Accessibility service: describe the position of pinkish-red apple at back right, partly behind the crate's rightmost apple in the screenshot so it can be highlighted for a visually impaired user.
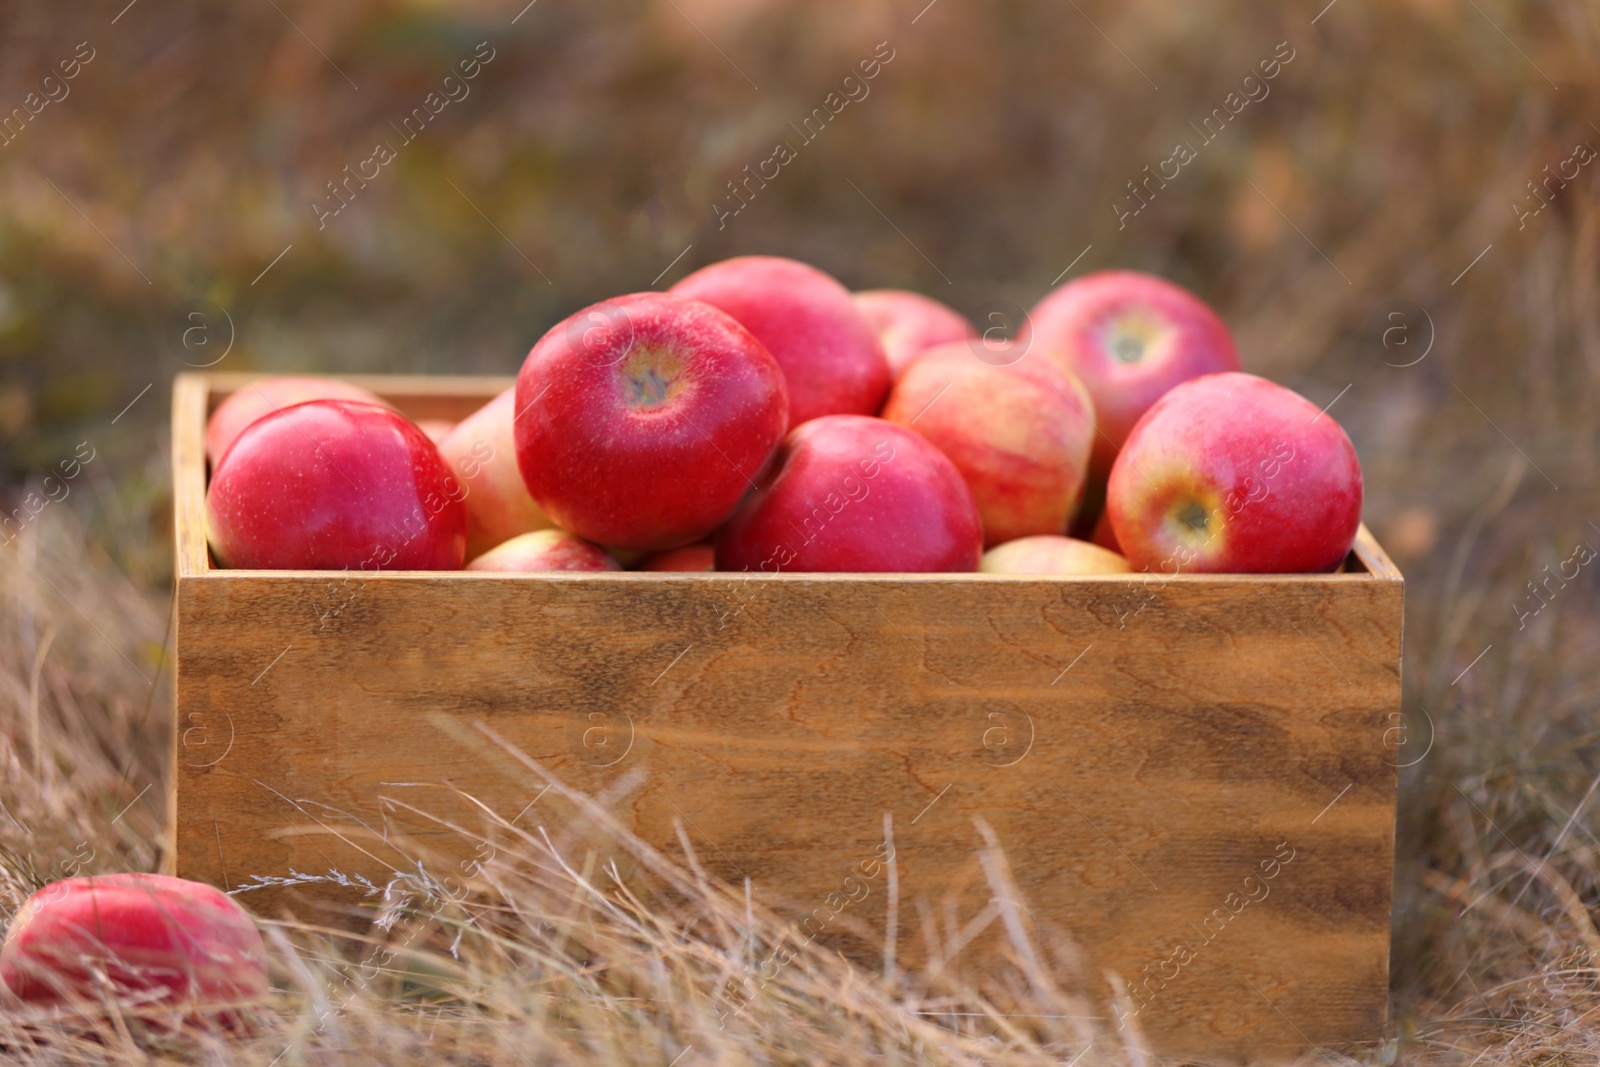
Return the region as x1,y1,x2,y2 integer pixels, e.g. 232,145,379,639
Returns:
1018,270,1238,478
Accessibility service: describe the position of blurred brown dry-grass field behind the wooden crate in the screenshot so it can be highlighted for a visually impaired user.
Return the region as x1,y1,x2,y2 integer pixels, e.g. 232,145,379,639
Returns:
0,0,1600,1064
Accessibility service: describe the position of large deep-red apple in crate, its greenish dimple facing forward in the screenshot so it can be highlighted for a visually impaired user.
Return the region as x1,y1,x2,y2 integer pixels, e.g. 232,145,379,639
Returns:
515,293,789,549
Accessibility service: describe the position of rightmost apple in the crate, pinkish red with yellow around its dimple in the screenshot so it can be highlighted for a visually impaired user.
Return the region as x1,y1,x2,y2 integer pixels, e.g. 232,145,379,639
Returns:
1106,371,1362,573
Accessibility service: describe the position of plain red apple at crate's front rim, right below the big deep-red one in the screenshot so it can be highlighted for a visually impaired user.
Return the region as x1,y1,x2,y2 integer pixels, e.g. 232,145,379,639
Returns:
717,414,984,573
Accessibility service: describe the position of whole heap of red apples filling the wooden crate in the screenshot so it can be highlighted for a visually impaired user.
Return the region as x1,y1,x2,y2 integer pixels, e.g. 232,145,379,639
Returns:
206,256,1362,574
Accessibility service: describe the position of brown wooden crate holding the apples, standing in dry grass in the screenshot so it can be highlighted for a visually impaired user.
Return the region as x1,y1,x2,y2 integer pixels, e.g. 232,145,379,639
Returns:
173,374,1402,1057
